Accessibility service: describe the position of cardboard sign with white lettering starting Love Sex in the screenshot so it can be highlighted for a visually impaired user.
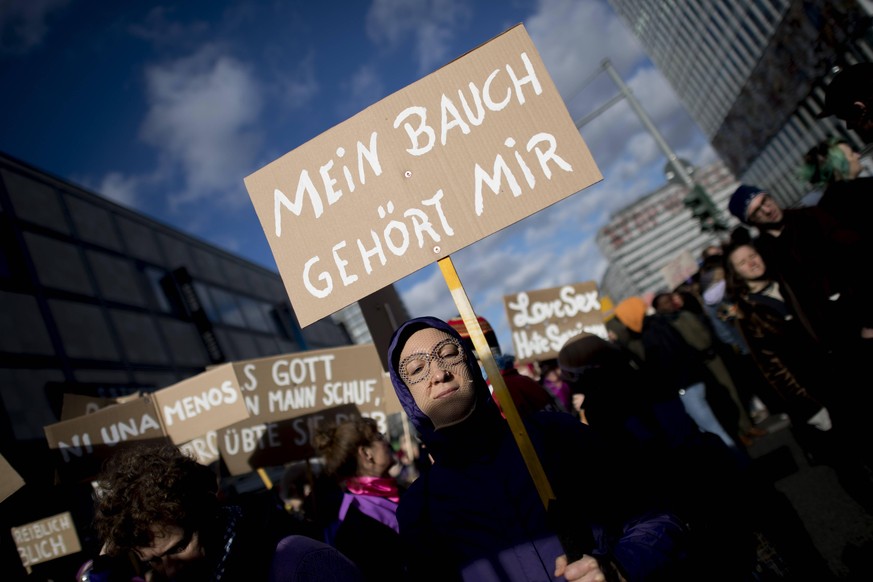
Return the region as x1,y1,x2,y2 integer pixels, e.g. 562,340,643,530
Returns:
503,281,607,363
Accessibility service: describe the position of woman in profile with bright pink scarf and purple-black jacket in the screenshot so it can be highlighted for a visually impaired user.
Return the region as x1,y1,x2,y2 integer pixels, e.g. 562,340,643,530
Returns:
312,417,403,580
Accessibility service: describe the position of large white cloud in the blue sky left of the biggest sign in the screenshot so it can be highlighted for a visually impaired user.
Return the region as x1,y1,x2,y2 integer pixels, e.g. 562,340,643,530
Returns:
140,46,262,207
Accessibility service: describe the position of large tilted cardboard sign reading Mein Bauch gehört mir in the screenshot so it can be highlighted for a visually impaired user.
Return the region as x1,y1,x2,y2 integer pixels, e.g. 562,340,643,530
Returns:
245,25,601,326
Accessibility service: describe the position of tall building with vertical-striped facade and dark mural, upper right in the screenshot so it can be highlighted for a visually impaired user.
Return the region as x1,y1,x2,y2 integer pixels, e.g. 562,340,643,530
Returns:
610,0,873,206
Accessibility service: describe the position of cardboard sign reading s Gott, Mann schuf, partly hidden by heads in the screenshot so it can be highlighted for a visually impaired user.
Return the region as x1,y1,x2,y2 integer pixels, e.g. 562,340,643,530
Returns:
218,344,386,472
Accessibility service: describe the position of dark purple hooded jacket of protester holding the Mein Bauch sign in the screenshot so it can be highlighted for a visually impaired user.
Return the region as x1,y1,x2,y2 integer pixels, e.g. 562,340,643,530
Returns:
388,318,686,582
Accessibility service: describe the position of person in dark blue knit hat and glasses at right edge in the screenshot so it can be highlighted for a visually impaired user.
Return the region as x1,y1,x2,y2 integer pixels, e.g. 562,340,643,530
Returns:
724,178,873,484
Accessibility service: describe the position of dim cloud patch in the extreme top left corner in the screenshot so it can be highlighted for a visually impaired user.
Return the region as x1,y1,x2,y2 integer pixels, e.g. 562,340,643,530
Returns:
0,0,70,55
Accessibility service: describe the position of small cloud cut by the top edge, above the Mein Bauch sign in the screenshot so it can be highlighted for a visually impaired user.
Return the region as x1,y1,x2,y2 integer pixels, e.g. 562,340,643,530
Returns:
367,0,472,75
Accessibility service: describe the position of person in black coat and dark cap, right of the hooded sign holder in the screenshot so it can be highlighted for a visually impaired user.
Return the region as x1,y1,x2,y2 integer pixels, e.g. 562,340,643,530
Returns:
558,334,830,582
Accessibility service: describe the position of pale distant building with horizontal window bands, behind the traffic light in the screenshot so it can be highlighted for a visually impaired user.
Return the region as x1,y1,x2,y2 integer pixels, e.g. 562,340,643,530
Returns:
596,162,739,303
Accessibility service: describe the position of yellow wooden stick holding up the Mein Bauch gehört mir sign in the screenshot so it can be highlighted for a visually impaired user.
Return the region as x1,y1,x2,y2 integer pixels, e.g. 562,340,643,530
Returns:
438,257,555,509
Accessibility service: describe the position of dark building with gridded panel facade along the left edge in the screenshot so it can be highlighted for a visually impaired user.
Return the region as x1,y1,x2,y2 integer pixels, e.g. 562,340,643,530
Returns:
0,154,370,450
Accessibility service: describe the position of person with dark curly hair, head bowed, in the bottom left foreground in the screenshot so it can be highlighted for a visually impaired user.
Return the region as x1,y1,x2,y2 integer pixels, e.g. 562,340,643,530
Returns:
82,444,360,582
